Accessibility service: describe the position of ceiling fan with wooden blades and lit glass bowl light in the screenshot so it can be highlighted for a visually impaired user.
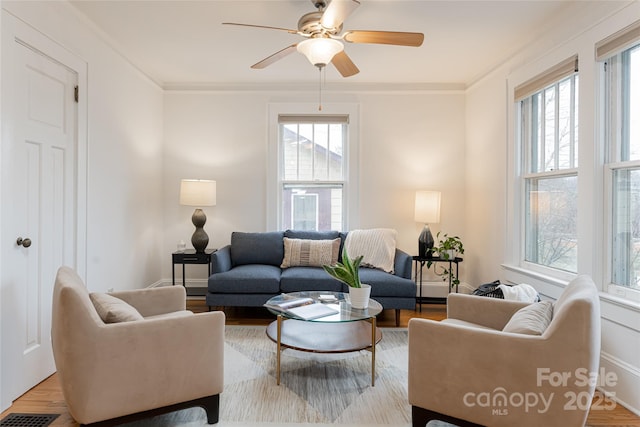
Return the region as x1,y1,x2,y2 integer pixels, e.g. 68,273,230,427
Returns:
223,0,424,77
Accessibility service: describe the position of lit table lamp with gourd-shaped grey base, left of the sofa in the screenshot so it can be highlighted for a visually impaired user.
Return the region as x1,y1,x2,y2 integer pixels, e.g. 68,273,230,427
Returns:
180,179,216,253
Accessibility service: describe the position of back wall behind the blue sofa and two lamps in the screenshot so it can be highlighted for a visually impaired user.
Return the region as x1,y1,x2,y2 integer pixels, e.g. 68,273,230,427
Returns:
163,88,465,282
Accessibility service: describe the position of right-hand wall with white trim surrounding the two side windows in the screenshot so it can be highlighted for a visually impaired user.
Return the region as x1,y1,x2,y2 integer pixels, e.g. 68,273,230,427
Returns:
465,2,640,414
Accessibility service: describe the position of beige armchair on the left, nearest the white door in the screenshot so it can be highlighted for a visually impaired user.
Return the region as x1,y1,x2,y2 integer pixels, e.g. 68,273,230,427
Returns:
52,267,225,425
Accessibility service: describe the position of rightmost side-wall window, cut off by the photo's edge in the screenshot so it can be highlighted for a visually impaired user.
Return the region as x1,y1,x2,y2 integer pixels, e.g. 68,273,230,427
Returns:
596,23,640,300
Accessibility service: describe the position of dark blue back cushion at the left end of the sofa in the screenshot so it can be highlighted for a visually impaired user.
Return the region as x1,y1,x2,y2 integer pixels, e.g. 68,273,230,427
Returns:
231,231,284,266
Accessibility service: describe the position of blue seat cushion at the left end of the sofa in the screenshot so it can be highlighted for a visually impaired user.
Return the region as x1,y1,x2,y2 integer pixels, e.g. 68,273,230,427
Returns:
208,264,280,294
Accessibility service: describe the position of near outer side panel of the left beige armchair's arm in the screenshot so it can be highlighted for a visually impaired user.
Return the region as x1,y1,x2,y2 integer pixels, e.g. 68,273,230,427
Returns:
62,312,224,424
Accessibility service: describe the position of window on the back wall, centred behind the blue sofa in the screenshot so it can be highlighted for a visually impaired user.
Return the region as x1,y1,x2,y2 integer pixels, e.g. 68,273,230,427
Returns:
278,115,348,230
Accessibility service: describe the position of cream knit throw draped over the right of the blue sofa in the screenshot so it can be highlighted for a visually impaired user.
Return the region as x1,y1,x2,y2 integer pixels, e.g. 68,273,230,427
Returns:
344,228,398,274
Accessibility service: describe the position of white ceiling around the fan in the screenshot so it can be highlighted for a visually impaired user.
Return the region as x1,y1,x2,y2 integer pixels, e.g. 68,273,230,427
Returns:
71,0,620,87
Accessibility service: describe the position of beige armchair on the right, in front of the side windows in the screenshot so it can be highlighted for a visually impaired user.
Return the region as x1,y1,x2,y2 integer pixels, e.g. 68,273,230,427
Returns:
409,276,600,427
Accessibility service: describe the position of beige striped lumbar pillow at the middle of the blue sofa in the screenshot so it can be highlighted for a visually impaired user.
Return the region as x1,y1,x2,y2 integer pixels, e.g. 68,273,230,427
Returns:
280,237,340,268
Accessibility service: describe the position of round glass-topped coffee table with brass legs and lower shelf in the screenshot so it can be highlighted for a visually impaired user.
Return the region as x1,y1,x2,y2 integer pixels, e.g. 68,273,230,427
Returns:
265,291,382,386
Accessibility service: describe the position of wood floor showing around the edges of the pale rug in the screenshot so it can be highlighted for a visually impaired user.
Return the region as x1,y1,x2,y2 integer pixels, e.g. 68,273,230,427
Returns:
0,299,640,427
